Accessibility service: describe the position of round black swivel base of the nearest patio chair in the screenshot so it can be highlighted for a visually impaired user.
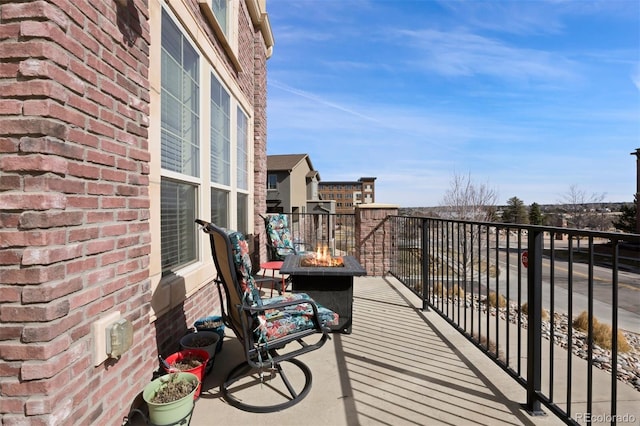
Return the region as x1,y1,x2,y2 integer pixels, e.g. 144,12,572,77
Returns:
220,358,311,413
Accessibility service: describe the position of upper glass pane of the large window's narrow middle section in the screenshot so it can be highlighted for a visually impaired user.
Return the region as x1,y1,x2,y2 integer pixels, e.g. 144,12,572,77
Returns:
211,75,231,186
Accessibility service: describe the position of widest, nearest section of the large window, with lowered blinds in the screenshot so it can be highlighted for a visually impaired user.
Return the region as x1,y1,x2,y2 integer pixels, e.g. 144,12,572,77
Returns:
160,11,200,273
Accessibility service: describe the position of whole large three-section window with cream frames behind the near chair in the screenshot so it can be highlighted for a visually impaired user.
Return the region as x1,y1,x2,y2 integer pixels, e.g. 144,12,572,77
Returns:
159,7,253,276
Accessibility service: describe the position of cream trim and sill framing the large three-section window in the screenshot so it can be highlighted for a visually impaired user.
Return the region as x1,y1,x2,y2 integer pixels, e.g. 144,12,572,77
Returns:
149,0,255,321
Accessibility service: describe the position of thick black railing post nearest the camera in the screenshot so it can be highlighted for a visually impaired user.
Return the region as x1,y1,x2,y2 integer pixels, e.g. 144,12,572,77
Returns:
525,228,544,416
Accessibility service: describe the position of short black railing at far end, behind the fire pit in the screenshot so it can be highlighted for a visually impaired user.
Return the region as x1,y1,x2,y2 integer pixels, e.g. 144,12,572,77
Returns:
274,213,355,256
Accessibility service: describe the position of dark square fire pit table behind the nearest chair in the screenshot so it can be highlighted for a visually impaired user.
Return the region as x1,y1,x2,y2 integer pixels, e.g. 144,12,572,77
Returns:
280,254,367,334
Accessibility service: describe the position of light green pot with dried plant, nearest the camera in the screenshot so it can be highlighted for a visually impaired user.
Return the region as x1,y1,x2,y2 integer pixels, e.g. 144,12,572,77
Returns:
142,372,200,425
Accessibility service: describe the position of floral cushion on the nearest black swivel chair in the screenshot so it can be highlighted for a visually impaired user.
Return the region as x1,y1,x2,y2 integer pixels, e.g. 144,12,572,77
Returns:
227,230,339,342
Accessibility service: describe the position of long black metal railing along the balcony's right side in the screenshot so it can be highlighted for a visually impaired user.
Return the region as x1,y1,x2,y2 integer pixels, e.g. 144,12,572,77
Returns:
385,216,640,424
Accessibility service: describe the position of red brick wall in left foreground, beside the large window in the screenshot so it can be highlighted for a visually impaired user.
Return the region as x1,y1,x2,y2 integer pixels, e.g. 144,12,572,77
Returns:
0,0,156,425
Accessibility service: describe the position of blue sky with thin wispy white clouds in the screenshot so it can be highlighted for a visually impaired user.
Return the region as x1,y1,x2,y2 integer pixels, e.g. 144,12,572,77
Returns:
267,0,640,207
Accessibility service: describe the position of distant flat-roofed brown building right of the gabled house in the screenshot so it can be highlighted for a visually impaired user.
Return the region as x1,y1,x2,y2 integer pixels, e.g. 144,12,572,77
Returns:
318,177,376,213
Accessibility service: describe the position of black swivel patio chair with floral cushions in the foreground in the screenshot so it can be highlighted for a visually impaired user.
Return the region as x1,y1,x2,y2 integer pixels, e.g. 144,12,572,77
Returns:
196,220,338,413
